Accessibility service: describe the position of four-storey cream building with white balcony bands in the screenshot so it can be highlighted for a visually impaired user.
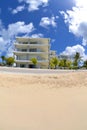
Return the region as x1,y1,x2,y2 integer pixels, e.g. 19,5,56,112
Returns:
14,37,55,68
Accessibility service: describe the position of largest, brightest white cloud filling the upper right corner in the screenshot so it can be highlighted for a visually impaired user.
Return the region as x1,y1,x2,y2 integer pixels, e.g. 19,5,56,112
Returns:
61,0,87,45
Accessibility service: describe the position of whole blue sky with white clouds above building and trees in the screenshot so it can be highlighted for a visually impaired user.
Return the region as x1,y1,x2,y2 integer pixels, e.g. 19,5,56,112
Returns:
0,0,87,60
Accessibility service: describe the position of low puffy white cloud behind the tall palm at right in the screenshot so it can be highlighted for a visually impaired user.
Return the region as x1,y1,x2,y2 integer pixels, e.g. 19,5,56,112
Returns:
60,44,87,60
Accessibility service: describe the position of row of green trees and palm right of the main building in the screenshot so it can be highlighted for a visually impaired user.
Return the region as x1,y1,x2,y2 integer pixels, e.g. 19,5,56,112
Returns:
50,52,87,69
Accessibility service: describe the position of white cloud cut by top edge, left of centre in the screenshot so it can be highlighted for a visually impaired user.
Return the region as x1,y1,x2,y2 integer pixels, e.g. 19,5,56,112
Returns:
18,0,49,11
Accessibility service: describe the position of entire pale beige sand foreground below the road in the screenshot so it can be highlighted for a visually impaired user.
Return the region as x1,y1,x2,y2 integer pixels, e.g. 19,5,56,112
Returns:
0,72,87,130
